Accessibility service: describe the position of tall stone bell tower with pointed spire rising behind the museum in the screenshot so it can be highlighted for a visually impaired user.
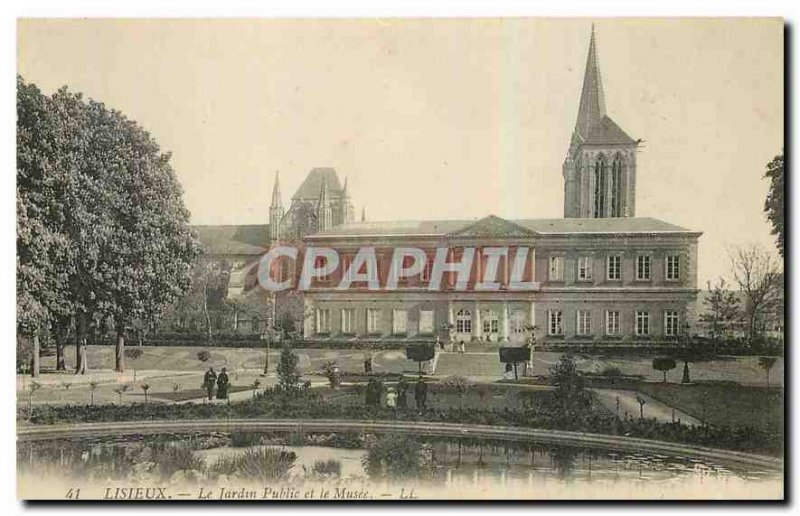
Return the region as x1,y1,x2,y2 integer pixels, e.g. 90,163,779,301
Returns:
562,25,639,218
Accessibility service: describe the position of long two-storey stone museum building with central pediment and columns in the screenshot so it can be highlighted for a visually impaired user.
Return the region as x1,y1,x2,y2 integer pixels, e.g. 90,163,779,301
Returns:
304,216,699,344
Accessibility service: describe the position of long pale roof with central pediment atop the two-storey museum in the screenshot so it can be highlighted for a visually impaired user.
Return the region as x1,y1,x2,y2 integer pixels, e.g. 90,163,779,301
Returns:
308,216,699,239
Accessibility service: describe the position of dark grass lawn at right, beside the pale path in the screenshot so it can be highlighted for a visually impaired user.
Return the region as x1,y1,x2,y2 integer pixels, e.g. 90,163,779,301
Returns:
636,382,783,431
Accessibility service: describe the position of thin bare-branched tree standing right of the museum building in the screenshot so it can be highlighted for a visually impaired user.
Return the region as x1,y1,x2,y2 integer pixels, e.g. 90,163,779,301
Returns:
731,245,783,341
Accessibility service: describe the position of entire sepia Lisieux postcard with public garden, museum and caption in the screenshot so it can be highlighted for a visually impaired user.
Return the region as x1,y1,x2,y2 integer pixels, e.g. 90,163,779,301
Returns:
16,17,787,503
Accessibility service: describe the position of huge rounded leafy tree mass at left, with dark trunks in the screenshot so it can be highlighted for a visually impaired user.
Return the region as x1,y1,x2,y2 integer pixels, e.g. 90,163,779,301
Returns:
17,79,198,373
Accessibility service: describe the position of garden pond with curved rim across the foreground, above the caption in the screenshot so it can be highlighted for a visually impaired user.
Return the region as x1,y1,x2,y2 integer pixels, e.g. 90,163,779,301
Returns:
18,433,782,498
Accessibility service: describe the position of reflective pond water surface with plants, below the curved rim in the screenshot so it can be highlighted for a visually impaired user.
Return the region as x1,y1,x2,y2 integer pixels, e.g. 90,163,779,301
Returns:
17,433,780,486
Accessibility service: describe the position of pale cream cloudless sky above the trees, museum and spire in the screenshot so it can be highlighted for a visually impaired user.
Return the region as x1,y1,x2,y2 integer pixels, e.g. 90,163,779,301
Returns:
17,18,784,287
